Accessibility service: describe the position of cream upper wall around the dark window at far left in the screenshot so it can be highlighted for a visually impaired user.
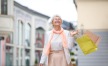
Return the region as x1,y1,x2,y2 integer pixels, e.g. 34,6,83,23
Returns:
0,0,14,35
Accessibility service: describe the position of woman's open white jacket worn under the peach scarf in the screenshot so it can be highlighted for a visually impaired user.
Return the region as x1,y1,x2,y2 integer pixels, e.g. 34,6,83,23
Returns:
40,30,74,65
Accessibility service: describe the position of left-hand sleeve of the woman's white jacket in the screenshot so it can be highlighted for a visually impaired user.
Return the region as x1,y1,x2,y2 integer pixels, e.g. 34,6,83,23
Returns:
40,32,48,64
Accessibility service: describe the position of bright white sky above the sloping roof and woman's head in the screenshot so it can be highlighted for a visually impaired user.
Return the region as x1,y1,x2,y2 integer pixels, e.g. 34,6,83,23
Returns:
15,0,77,22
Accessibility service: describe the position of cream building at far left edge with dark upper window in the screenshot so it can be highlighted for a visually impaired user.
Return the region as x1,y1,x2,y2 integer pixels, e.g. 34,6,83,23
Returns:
0,0,14,66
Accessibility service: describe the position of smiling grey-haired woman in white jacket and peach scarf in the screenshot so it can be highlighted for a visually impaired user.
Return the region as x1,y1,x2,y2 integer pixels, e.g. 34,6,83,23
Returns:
40,15,78,66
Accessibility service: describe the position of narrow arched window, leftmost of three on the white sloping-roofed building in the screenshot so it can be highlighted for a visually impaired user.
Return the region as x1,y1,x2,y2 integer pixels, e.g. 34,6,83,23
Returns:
18,20,23,45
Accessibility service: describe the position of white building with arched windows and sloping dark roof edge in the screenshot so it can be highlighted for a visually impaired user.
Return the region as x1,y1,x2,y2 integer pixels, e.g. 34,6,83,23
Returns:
14,2,49,66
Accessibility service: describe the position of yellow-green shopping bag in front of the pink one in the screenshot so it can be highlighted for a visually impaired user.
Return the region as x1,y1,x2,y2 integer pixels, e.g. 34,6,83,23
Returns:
76,34,97,55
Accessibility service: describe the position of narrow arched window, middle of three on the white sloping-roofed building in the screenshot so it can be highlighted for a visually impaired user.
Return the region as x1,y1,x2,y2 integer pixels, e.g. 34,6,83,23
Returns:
25,24,31,46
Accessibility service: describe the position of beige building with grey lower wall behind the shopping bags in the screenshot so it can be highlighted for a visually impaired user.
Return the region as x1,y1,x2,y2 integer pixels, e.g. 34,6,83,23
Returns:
76,0,108,66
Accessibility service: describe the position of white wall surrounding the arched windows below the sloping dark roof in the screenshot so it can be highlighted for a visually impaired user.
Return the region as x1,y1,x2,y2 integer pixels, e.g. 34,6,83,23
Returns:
14,3,48,65
